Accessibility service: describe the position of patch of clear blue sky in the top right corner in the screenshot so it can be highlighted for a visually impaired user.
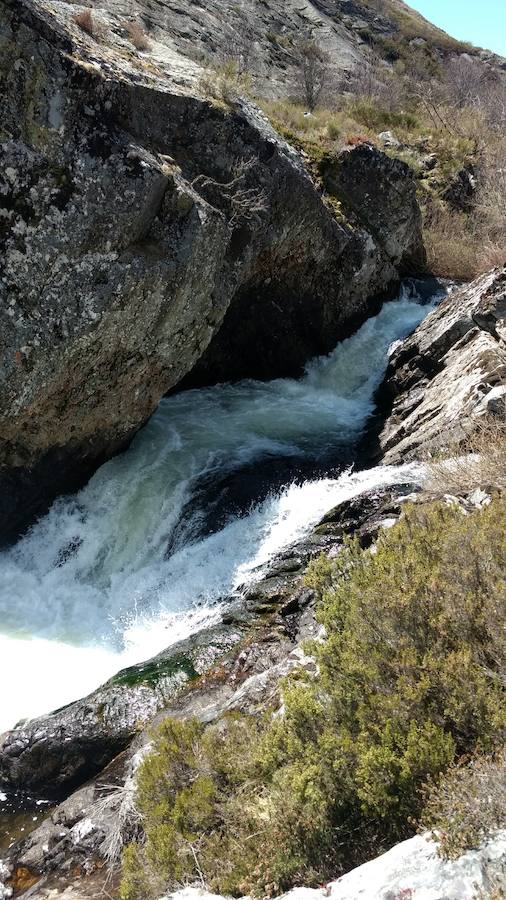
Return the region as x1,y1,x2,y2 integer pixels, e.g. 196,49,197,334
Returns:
406,0,506,56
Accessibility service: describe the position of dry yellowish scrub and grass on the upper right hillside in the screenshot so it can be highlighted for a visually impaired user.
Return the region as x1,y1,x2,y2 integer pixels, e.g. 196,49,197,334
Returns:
253,28,506,280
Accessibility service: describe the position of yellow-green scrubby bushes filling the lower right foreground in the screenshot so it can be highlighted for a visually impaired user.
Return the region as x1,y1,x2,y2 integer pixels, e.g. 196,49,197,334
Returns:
121,496,506,900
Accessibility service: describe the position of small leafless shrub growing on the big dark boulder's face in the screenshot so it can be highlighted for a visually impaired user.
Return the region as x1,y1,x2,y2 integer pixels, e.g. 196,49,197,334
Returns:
192,159,268,227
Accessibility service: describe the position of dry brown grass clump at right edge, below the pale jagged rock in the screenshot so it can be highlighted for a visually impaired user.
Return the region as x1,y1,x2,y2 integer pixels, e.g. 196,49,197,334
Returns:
427,420,506,494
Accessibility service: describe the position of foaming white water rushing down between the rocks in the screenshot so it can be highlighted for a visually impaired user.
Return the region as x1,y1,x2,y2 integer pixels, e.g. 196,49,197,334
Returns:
0,282,440,732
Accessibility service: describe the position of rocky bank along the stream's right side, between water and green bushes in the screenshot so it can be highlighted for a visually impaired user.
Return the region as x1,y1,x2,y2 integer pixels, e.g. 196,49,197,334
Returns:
0,271,505,896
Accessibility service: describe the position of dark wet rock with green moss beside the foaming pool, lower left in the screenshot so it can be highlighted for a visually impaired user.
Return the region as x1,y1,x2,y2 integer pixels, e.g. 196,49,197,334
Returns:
0,617,242,798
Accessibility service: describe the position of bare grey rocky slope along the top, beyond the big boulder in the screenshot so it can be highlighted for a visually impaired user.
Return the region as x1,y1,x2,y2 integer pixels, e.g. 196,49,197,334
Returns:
34,0,506,98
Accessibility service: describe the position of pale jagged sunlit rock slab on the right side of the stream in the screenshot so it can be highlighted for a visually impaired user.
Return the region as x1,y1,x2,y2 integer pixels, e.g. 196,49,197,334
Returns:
378,269,506,463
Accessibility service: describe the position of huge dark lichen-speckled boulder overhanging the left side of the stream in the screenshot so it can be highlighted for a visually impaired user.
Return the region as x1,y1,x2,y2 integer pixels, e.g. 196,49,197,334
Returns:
0,0,421,540
